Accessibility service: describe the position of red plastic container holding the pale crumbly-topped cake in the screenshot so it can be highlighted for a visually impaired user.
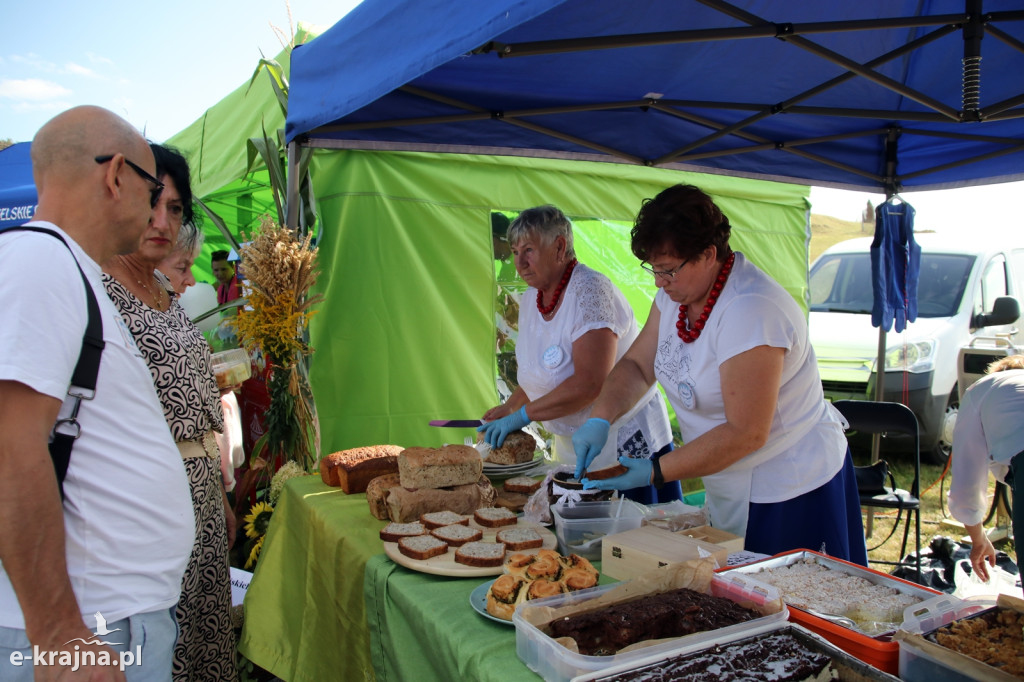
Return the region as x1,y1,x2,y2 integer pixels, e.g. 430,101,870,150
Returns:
724,550,940,675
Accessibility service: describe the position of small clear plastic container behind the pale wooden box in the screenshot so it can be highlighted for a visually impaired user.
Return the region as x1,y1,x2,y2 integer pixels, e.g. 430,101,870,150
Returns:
551,498,644,561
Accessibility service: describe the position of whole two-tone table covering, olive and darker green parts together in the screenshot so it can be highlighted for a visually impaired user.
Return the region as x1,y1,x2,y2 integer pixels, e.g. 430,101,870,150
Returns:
239,476,540,682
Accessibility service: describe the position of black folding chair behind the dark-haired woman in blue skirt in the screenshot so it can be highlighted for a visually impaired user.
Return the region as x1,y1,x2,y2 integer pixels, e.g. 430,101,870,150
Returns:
833,400,921,580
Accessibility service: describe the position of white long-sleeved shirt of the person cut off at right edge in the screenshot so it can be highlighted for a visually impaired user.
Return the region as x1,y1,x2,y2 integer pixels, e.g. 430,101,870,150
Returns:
949,370,1024,525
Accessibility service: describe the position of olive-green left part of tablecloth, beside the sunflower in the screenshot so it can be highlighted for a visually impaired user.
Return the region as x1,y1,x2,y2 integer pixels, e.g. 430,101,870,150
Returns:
239,476,387,682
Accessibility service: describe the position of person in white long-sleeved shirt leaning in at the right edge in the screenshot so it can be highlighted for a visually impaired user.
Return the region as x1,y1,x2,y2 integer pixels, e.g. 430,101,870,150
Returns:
948,355,1024,582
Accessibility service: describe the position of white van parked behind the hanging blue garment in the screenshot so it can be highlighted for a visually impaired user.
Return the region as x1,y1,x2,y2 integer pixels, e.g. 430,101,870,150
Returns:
809,233,1024,464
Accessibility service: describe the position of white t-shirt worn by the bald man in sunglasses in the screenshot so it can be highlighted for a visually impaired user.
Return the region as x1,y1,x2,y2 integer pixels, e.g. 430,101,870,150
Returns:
0,222,196,629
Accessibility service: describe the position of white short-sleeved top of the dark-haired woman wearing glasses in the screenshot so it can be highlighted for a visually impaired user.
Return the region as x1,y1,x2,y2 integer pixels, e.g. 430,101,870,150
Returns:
654,252,847,503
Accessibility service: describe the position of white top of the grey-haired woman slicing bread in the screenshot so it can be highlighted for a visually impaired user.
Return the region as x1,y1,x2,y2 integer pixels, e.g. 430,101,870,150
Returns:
515,263,672,465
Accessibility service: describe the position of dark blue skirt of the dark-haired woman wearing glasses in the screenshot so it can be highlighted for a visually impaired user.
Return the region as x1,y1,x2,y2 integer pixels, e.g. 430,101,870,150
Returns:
744,447,867,566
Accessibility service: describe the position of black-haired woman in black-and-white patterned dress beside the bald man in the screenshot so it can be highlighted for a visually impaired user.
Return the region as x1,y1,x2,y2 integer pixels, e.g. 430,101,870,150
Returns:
103,144,238,681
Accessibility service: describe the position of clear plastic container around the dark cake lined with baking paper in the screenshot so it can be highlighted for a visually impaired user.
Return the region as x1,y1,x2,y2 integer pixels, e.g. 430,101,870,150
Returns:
512,573,788,682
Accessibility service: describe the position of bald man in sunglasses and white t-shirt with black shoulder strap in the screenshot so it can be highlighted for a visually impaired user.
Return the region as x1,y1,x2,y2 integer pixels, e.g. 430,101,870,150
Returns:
0,106,196,682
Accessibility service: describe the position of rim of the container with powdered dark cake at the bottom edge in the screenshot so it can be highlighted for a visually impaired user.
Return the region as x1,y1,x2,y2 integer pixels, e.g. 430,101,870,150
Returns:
572,623,898,682
